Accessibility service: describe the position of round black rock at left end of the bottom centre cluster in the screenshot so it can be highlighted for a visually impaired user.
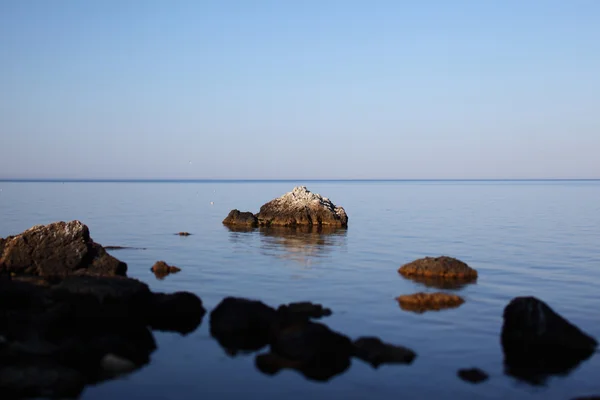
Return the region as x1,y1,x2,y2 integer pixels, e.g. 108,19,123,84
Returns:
210,297,277,355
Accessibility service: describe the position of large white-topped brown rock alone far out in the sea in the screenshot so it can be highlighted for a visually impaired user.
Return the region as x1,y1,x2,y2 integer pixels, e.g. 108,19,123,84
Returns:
256,186,348,227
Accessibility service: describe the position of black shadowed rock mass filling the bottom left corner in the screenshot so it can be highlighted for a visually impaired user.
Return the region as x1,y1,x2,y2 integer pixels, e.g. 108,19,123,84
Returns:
0,275,205,399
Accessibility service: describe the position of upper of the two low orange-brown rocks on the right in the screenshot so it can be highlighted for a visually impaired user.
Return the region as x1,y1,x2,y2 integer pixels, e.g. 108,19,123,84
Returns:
398,256,477,280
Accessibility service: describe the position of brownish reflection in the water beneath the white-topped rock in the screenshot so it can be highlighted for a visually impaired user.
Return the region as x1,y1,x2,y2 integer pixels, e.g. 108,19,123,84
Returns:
258,226,346,264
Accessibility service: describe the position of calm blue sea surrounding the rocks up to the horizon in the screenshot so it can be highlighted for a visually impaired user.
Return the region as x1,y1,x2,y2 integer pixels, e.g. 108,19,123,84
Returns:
0,181,600,400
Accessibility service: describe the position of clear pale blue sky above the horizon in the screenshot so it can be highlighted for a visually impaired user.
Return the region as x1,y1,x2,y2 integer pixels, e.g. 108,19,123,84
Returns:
0,0,600,179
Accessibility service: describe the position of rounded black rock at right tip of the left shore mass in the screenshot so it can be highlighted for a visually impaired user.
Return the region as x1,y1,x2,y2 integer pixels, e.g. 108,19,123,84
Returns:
150,292,206,335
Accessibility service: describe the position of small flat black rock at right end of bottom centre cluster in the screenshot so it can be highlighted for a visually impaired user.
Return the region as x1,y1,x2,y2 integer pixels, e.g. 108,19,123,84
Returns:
354,337,417,368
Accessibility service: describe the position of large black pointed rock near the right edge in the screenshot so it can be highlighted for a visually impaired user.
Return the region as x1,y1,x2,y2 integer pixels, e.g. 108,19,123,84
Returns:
501,297,598,384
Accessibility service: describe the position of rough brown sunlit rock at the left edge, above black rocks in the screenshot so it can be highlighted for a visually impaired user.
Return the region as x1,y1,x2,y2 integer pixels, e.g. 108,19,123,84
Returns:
0,221,127,276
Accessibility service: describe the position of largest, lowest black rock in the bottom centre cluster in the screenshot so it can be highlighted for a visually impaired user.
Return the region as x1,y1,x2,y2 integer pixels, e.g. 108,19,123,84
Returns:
256,321,354,381
